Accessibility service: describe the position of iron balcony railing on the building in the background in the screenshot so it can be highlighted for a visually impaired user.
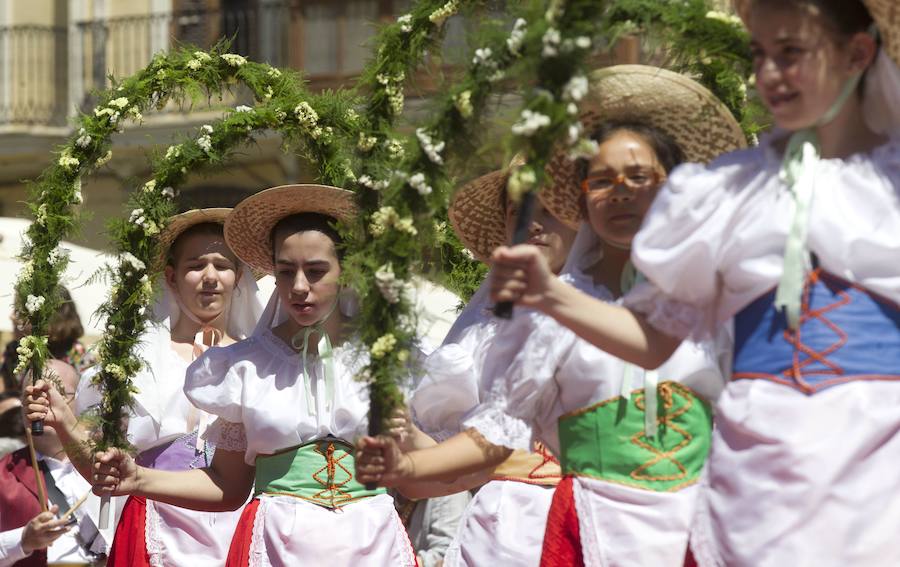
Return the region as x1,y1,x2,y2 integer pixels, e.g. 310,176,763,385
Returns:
0,0,422,130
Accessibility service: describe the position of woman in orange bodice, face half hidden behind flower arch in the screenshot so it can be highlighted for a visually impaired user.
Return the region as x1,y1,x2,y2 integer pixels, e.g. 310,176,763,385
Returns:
396,160,575,567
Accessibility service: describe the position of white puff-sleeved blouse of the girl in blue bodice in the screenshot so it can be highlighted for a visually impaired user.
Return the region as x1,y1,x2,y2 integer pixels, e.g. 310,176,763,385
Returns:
625,137,900,337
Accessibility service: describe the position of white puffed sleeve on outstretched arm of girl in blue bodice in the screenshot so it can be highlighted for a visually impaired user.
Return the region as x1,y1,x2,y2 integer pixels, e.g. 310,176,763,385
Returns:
624,150,761,338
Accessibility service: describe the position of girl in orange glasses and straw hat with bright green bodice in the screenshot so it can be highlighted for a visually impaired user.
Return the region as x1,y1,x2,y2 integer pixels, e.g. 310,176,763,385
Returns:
360,66,744,566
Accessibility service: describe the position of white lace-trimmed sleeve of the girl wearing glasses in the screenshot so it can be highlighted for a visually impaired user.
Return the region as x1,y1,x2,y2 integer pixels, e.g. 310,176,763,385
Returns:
464,313,575,451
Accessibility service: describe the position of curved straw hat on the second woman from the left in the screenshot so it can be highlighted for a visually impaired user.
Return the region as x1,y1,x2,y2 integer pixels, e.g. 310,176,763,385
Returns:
225,184,358,274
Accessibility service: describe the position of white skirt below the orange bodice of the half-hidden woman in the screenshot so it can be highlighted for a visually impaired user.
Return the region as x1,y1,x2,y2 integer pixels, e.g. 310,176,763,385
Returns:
444,480,553,567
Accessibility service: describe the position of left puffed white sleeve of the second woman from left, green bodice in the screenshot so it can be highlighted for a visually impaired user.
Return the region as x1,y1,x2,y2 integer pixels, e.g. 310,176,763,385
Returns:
184,345,244,423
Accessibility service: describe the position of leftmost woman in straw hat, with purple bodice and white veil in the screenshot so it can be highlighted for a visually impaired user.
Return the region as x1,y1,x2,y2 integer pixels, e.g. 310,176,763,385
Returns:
28,209,262,567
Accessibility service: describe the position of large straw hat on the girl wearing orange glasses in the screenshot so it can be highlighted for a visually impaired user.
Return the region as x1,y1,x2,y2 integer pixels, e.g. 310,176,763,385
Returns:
539,65,747,227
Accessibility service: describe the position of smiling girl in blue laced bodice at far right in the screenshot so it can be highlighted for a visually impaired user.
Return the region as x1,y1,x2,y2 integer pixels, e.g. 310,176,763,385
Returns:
494,0,900,566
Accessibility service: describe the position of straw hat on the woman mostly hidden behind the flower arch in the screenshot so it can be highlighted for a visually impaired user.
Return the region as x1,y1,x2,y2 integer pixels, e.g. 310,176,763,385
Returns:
447,156,524,263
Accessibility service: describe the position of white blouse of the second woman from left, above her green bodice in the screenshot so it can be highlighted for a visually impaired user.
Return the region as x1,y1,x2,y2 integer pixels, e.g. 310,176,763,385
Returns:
184,329,369,465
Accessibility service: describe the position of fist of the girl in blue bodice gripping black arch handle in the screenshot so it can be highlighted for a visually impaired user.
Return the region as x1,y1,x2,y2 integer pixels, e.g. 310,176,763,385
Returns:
491,245,556,307
